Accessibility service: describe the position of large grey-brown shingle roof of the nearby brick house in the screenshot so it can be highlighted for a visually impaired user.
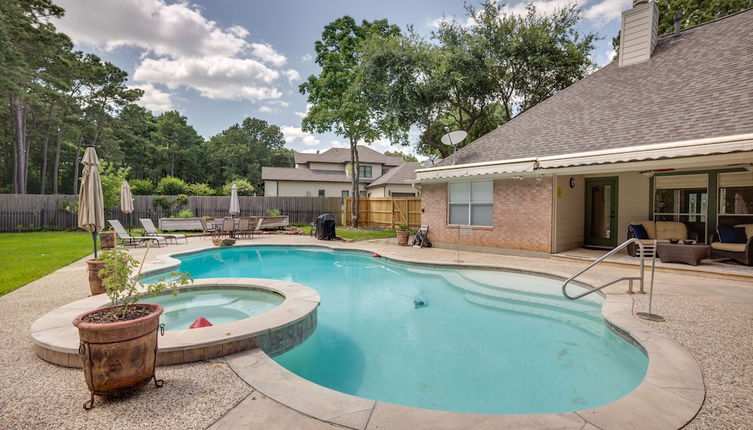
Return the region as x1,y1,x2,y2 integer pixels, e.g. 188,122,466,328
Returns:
438,9,753,166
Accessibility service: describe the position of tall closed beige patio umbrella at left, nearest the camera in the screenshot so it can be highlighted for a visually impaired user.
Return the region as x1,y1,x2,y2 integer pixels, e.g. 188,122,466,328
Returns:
78,146,105,258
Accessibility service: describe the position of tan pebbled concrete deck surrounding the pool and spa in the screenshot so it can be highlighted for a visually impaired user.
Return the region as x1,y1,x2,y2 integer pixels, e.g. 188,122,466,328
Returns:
0,236,753,429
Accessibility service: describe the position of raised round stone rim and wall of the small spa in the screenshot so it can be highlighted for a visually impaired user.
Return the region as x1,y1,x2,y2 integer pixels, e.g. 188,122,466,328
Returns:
31,278,320,367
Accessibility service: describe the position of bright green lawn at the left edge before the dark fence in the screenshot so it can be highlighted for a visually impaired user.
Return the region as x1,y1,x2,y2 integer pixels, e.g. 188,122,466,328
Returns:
0,232,92,296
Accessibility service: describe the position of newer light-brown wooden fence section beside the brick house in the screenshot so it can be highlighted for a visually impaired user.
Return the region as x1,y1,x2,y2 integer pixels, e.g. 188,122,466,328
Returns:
342,197,421,230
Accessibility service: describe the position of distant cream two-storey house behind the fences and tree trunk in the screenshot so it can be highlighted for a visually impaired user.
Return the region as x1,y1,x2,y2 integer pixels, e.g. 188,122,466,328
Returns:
261,145,419,197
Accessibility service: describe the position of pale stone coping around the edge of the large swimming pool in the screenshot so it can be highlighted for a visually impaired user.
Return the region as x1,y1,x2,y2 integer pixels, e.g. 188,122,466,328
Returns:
44,244,706,430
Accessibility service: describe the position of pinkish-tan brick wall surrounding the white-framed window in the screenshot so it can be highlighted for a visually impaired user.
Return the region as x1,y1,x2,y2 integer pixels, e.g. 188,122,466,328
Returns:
421,177,552,252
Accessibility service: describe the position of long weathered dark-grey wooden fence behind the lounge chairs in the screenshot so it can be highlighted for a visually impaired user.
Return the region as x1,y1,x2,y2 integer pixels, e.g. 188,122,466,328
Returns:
0,194,342,231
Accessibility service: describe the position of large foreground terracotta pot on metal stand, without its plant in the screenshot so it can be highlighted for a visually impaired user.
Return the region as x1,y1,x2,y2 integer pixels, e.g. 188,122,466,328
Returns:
73,303,163,409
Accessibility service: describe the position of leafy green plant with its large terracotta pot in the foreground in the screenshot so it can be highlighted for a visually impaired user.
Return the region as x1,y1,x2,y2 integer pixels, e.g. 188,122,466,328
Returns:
73,248,192,409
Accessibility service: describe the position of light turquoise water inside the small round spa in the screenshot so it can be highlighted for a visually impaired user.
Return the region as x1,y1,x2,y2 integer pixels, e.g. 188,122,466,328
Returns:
144,289,284,330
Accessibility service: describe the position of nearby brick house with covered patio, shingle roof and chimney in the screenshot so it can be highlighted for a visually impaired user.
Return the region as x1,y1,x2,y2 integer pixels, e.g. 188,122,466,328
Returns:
416,1,753,253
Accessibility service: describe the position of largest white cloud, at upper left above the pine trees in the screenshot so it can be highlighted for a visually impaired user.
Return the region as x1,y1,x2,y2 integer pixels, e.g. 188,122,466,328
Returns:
55,0,291,105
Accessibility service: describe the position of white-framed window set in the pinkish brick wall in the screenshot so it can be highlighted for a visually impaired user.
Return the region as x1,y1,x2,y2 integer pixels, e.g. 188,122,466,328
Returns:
448,181,493,226
